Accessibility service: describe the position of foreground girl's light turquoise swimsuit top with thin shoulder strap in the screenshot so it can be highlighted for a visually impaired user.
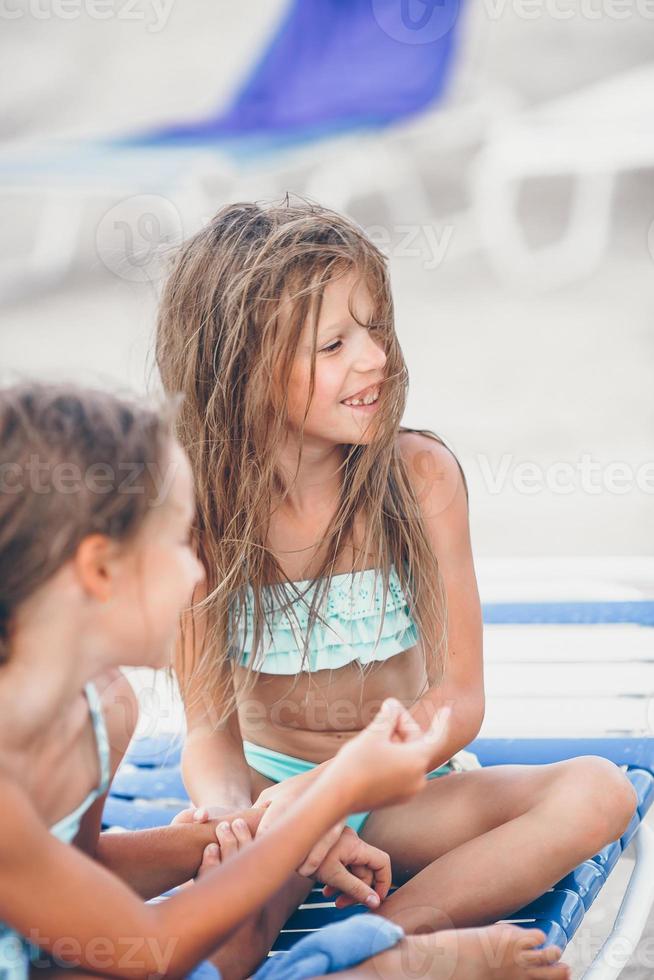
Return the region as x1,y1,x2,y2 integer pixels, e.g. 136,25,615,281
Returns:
0,684,111,980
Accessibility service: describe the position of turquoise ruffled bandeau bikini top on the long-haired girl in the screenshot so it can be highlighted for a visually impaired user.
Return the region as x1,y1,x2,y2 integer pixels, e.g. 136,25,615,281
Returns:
231,566,418,674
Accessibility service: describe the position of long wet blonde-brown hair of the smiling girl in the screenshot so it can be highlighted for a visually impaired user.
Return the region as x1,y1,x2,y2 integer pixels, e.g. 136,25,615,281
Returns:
155,199,464,720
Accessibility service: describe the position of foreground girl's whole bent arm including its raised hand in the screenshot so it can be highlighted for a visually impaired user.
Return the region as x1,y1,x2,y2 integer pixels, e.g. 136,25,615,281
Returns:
0,702,440,978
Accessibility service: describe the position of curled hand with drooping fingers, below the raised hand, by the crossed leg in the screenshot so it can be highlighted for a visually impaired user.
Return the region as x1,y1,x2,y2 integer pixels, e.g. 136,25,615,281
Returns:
308,827,391,909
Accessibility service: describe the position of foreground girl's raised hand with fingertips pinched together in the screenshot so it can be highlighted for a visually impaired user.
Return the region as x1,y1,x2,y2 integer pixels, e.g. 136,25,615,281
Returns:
336,698,452,813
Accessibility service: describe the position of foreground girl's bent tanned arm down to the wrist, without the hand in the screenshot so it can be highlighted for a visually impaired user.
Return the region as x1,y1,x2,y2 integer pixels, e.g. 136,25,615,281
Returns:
0,768,346,978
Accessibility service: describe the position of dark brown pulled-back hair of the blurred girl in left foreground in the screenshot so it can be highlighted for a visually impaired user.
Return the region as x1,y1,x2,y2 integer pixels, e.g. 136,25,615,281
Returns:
0,382,176,663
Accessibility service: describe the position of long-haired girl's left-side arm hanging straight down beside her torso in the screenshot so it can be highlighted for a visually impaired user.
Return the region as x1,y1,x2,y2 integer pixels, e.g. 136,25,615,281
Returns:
175,584,252,814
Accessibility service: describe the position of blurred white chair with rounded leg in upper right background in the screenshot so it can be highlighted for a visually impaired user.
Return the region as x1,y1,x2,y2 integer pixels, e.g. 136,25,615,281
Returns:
472,64,654,289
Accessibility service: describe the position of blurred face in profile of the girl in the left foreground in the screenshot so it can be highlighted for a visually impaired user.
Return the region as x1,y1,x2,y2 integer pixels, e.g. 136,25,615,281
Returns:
108,442,204,667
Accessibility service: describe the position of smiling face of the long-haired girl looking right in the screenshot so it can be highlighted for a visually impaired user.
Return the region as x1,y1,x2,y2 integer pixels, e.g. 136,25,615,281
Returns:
288,271,386,445
